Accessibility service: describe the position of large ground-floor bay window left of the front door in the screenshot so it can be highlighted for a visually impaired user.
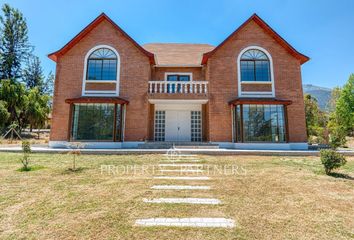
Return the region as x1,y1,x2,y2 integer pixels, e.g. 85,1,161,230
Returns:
71,103,123,141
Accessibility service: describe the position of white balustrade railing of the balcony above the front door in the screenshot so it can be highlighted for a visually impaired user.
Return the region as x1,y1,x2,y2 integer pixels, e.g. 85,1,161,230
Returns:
149,81,208,94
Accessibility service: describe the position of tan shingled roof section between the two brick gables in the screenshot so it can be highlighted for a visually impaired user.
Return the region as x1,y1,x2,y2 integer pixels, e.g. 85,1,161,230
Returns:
143,43,215,67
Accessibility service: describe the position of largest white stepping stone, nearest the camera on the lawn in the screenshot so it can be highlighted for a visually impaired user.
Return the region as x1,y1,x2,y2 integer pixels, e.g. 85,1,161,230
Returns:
135,218,235,228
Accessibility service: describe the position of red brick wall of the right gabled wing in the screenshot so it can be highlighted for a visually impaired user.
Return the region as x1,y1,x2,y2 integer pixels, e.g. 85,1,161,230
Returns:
206,21,307,142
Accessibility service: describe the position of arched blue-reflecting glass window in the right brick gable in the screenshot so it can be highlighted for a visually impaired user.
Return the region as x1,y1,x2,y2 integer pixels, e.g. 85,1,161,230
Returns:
240,49,271,82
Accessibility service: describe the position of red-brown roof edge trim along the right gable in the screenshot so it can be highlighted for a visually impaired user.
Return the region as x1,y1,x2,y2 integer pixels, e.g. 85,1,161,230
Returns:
202,14,310,64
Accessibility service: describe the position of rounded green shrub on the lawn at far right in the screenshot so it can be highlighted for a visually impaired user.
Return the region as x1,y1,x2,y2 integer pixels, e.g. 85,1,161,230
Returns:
320,149,347,175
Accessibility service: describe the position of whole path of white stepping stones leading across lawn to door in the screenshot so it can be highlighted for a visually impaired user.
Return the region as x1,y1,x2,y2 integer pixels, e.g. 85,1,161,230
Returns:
135,149,235,228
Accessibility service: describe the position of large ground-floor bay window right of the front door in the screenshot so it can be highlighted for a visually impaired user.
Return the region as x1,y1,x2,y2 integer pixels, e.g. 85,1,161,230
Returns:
234,104,286,142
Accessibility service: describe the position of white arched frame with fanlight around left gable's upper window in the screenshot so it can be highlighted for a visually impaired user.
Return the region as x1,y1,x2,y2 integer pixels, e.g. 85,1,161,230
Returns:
82,45,120,96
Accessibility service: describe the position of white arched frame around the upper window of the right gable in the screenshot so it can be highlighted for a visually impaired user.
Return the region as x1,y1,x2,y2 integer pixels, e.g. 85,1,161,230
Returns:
237,46,275,97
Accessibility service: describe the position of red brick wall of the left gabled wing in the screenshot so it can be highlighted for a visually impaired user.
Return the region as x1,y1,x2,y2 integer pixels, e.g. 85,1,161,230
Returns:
50,21,151,141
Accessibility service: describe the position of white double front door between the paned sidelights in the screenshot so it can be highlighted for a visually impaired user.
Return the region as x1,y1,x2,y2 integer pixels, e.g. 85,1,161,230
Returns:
165,110,191,142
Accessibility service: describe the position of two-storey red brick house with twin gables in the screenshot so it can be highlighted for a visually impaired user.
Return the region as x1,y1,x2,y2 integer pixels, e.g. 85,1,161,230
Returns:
49,14,309,149
